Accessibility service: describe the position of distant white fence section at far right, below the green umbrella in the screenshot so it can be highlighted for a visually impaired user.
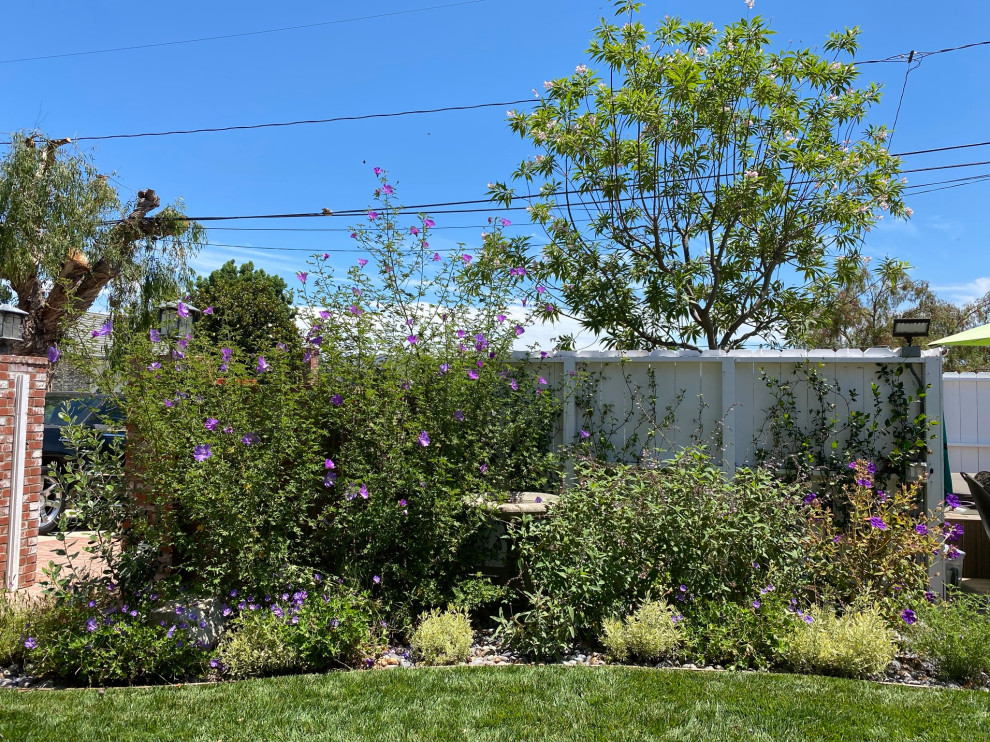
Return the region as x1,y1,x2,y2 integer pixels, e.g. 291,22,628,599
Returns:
942,373,990,473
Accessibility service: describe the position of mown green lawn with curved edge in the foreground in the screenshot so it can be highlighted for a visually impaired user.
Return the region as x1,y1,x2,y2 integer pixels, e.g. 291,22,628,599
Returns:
0,666,990,742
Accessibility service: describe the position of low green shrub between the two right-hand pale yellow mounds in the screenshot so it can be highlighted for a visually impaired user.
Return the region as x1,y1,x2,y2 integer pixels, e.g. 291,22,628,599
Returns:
682,588,791,669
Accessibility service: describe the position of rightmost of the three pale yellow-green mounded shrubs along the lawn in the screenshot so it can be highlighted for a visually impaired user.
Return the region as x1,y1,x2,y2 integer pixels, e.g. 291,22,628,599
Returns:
783,607,897,677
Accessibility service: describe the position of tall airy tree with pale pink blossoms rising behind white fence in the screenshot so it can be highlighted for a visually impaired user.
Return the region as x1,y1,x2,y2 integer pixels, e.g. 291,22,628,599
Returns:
489,2,910,349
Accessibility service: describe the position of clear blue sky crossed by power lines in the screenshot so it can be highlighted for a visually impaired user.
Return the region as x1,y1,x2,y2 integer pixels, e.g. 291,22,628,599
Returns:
0,0,990,348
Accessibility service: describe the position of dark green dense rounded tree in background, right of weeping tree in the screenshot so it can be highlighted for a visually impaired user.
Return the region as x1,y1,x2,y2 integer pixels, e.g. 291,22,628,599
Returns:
190,260,300,353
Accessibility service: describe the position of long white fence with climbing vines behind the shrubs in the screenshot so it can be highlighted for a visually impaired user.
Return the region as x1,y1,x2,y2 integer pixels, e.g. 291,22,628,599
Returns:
516,348,944,507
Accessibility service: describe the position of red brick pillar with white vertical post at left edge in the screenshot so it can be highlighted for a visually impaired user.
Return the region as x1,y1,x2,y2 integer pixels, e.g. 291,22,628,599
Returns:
0,355,48,590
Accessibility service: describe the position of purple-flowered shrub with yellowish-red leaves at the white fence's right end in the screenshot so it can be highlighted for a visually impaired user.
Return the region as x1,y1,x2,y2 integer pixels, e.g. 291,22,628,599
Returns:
804,461,952,621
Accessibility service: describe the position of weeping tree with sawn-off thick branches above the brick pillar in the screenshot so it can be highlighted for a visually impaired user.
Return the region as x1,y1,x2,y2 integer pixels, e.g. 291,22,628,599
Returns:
0,133,201,355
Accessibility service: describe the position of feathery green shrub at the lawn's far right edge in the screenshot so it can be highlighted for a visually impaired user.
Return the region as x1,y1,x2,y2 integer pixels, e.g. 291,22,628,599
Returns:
907,591,990,680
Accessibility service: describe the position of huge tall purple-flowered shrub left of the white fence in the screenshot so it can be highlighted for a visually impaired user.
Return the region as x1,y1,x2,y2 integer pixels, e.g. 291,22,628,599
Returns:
76,171,560,620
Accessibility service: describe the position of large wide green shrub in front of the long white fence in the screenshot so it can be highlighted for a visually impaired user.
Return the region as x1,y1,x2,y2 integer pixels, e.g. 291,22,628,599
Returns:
499,450,805,656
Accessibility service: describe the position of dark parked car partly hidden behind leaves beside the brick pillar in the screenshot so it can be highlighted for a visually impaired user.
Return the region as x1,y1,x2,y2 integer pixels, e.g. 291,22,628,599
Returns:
38,392,124,534
